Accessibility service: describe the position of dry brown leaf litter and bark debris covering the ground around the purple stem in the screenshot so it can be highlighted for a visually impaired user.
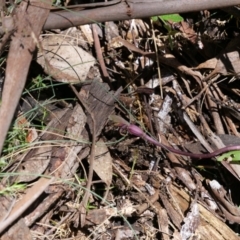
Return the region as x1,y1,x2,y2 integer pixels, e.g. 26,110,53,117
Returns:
0,4,240,240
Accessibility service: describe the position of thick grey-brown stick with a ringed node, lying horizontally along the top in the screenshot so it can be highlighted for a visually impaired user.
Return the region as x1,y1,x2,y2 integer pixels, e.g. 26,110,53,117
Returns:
44,0,239,30
